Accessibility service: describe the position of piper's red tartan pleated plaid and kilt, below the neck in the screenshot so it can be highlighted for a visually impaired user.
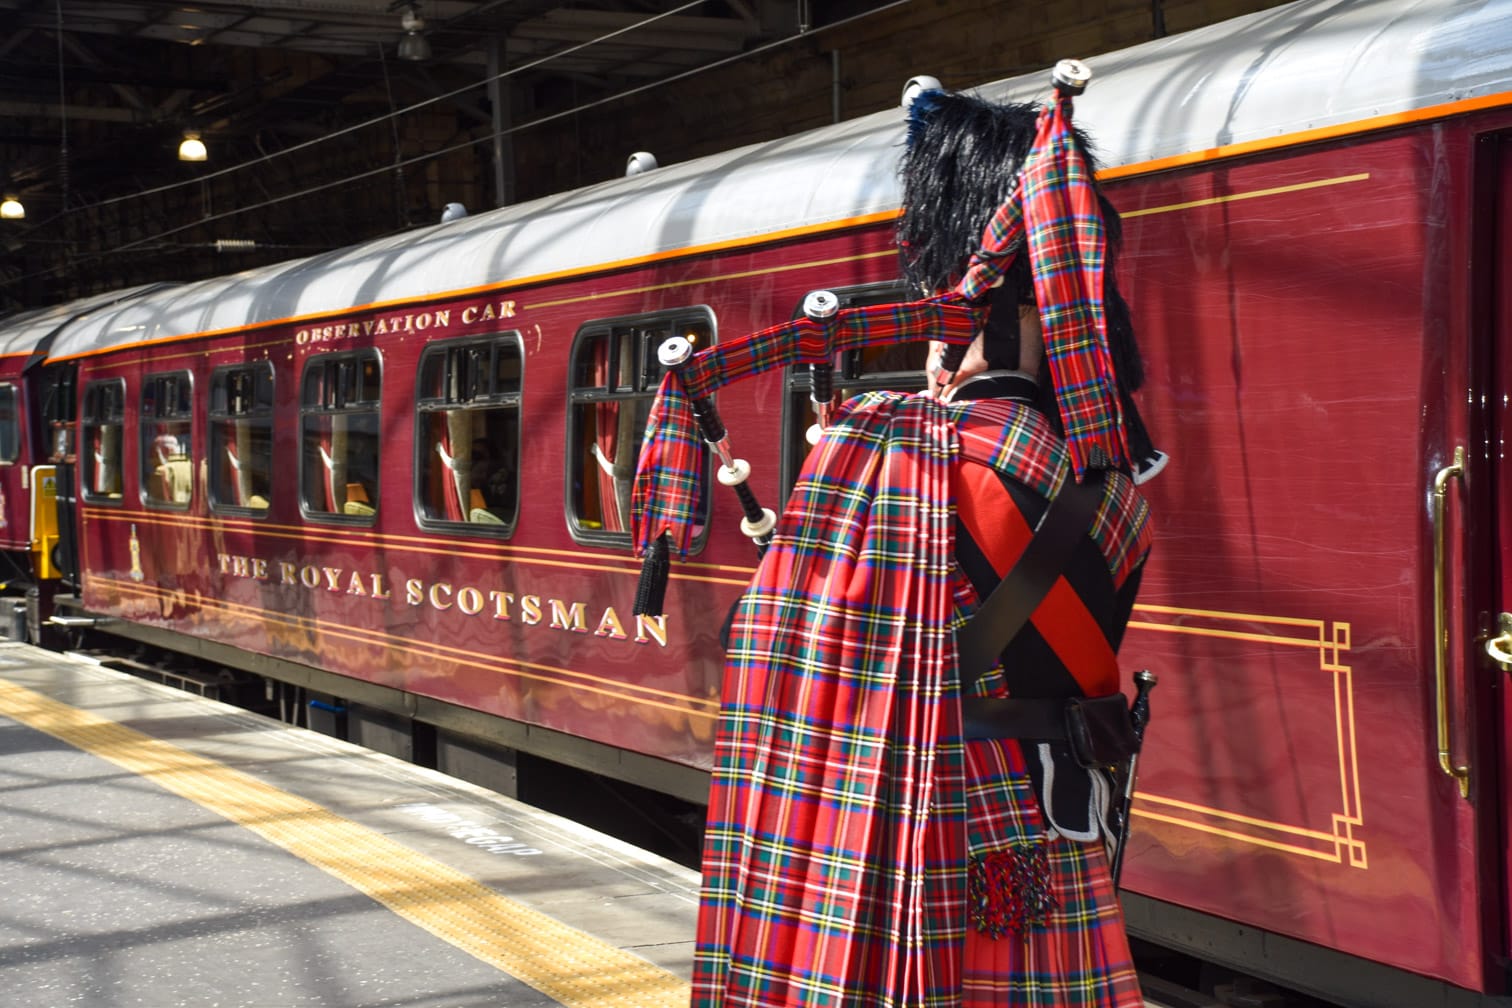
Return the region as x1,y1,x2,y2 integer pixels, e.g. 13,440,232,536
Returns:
694,393,1148,1008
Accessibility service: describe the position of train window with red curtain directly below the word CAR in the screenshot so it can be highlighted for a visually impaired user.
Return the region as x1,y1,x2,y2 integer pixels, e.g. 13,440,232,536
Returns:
414,332,525,533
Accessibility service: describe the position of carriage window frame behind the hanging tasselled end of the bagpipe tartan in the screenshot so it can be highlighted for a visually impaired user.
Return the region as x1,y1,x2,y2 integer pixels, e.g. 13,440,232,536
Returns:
562,304,718,555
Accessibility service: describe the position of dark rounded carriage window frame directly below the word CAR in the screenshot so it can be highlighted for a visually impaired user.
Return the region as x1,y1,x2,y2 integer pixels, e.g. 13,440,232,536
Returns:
411,329,525,538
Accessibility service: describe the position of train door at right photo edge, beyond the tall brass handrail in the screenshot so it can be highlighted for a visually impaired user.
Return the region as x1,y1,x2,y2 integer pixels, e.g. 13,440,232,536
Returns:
1470,131,1512,991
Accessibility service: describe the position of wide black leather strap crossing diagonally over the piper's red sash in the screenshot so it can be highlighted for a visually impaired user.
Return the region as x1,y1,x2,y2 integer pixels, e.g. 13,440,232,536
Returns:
956,468,1107,695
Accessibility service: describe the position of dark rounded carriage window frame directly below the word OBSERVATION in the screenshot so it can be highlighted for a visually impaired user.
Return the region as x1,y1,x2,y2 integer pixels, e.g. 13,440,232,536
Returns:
298,348,383,526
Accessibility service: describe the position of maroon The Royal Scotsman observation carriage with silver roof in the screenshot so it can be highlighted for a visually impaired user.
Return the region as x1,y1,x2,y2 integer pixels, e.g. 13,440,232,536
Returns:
17,0,1512,1008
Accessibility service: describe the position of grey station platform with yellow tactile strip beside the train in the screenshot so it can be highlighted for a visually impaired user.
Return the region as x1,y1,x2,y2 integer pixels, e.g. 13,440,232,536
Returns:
0,642,699,1008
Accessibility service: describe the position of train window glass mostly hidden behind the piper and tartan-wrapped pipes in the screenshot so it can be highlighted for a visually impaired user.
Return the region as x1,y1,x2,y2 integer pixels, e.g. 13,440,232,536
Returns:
782,281,928,497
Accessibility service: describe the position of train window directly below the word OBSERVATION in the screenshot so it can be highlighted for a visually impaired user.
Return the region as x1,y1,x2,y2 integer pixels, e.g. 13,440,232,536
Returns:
299,351,381,523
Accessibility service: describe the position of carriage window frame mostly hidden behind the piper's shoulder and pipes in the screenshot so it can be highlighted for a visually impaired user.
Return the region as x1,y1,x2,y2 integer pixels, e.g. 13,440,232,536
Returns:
777,280,927,502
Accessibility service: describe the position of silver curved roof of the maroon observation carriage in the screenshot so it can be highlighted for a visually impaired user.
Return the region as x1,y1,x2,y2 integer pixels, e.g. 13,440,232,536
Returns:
41,0,1512,358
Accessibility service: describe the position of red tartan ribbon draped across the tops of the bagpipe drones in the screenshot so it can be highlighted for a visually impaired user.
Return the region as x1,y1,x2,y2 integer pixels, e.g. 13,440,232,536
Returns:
631,87,1129,568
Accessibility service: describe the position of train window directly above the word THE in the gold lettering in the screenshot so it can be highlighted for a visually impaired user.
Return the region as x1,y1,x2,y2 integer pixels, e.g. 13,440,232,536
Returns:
209,361,274,514
